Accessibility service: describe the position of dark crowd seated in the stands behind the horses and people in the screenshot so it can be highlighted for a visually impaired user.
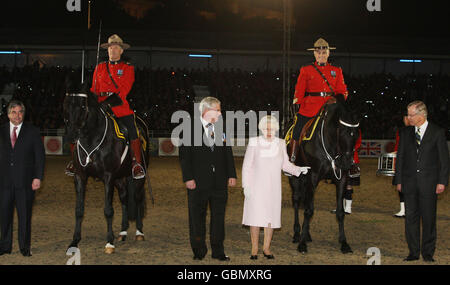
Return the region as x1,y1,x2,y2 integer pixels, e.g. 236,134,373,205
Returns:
0,64,450,139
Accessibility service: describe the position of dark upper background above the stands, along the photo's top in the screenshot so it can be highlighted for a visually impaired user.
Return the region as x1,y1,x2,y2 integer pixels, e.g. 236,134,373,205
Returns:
0,0,450,54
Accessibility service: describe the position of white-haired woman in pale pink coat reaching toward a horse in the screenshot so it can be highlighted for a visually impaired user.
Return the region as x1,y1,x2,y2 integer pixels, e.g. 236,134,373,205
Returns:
242,115,309,259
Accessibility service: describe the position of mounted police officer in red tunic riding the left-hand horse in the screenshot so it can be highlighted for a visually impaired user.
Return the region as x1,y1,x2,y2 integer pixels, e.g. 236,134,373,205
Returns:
66,34,145,179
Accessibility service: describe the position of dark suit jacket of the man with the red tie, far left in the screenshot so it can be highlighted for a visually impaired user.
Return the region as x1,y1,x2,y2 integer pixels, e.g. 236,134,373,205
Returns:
0,122,45,189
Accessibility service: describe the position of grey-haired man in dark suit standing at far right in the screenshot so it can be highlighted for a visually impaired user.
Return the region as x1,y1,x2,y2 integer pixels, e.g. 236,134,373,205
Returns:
394,101,449,262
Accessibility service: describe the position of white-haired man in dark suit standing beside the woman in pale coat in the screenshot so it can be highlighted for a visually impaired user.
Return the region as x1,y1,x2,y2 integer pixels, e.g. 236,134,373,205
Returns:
179,97,236,261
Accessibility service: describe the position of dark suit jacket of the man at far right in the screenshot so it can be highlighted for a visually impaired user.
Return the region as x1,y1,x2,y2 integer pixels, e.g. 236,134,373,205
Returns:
394,121,449,194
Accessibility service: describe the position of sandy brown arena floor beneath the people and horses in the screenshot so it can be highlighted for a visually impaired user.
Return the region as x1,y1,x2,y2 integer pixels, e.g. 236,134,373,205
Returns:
0,156,450,265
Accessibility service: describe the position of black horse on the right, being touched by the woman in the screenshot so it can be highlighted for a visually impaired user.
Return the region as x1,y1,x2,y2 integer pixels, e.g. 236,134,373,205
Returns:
289,95,359,253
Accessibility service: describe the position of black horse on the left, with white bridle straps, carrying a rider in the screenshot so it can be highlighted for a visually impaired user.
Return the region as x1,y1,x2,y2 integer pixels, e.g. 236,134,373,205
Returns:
64,83,151,253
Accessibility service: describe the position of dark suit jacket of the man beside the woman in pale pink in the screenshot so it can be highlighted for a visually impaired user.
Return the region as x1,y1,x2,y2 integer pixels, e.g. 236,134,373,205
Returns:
179,118,236,190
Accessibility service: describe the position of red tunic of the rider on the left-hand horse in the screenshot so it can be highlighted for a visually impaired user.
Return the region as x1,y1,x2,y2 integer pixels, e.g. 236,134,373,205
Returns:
91,61,134,118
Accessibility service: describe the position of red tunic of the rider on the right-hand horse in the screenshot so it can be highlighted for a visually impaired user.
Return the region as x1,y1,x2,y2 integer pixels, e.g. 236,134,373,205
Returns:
294,62,348,117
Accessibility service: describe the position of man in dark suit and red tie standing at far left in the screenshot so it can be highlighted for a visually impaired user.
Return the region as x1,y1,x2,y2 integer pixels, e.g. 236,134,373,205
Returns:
0,100,45,256
